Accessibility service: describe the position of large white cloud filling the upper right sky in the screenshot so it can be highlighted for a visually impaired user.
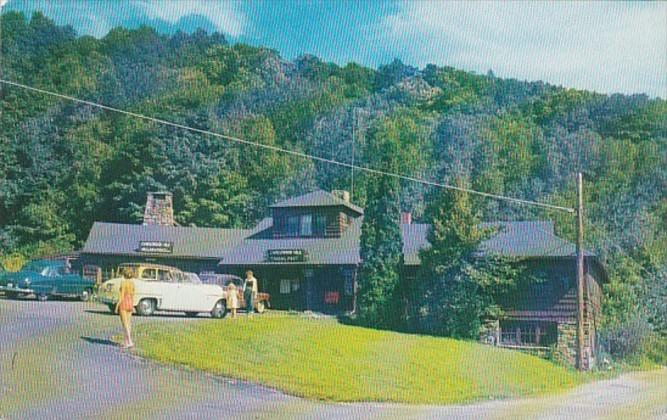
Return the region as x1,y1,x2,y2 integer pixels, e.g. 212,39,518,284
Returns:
375,2,667,98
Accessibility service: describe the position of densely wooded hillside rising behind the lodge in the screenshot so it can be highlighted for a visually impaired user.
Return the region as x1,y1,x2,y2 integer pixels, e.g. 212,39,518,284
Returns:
0,13,667,342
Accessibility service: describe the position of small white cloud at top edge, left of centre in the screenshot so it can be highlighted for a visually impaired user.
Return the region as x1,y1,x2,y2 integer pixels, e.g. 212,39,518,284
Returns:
136,0,247,37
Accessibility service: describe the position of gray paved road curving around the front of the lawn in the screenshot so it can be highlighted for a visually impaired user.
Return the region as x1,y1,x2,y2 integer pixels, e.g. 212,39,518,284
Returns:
0,298,667,420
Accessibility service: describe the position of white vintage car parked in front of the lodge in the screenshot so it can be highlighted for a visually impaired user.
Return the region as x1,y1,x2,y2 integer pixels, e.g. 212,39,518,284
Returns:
98,263,227,318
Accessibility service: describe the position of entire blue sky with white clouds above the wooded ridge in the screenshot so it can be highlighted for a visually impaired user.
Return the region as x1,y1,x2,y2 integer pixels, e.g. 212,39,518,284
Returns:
0,0,667,98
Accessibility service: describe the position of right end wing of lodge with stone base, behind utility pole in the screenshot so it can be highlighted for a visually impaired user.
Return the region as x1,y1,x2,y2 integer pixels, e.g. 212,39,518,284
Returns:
481,222,607,366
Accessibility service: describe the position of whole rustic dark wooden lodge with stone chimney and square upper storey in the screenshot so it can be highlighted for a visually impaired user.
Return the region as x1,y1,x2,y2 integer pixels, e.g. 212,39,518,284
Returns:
80,190,606,364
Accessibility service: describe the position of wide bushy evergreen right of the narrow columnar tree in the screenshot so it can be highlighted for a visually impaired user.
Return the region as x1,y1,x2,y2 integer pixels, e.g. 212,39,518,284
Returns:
410,182,522,338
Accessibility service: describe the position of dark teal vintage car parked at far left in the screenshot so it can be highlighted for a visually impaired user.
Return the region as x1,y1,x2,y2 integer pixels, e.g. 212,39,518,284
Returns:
0,260,95,301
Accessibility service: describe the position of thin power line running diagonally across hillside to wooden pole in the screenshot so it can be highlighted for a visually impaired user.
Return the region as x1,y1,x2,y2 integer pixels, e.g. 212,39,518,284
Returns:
0,79,576,213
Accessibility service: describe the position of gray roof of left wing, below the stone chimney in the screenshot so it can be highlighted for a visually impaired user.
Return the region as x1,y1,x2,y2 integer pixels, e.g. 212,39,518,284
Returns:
81,222,250,259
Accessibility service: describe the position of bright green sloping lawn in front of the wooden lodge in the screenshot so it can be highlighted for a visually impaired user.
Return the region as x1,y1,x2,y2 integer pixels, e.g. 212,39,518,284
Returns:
136,313,585,404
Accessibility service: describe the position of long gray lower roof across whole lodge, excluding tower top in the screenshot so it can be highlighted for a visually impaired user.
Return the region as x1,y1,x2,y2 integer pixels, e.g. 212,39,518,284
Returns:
82,216,593,265
